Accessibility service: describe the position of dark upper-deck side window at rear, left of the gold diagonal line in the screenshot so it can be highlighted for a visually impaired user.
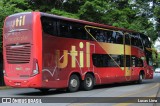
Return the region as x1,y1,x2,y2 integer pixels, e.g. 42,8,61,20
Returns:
41,16,87,40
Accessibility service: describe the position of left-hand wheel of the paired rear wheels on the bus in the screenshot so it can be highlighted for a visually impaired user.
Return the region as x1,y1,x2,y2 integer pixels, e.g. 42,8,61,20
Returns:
68,74,80,92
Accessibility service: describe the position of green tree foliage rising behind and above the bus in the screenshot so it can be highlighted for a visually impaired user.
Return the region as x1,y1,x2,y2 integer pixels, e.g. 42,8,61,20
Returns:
0,0,160,52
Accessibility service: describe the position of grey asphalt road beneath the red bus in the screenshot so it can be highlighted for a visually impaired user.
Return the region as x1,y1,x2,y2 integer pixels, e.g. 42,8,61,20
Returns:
0,73,160,106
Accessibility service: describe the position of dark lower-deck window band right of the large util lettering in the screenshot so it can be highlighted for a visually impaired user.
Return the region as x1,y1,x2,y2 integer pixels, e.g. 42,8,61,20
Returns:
92,54,134,67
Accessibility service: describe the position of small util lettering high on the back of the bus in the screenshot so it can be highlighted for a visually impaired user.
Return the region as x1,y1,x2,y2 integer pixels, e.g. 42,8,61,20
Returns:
11,15,26,28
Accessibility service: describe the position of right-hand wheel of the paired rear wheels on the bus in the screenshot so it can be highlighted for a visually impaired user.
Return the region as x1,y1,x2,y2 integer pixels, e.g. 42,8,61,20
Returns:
81,74,94,91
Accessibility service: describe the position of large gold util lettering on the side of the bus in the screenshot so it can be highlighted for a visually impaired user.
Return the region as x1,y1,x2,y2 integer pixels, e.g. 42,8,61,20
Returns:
56,42,90,68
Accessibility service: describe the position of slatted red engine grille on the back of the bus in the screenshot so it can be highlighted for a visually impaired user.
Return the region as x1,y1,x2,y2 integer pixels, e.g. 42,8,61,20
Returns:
6,44,31,64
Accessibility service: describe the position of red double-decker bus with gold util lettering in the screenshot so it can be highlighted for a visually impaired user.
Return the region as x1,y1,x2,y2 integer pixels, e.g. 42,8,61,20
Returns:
3,12,153,92
